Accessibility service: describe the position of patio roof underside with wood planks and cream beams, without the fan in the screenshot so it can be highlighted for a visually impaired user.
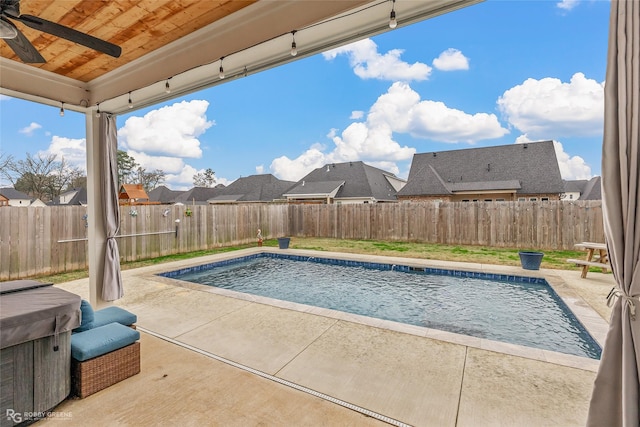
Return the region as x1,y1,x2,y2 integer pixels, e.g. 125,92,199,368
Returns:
0,0,482,114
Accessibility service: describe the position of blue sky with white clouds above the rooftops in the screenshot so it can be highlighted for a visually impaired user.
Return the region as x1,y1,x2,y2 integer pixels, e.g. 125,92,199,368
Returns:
0,0,609,190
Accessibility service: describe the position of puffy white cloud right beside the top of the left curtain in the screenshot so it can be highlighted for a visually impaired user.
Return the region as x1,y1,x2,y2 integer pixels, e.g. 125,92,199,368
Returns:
118,100,214,158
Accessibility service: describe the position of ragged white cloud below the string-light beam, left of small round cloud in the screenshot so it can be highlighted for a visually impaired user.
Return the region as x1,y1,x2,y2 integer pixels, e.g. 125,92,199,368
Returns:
322,39,432,82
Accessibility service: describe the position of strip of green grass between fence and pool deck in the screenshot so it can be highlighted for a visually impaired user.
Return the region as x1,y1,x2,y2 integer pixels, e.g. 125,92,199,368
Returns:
39,237,600,283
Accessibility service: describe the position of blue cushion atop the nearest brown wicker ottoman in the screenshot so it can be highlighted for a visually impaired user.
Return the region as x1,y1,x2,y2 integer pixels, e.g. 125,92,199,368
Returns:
71,323,140,362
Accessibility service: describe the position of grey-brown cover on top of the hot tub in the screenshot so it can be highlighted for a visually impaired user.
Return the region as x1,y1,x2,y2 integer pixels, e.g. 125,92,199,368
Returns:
0,280,80,348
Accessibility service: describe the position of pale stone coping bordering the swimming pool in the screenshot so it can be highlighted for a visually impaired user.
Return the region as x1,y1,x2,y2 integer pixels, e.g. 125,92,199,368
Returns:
148,247,609,372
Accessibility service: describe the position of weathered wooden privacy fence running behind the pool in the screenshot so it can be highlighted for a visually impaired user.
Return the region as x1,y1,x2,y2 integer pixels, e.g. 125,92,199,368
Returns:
0,200,604,280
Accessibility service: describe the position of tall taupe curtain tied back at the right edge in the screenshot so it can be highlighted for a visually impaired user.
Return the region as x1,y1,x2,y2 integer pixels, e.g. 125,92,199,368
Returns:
587,0,640,427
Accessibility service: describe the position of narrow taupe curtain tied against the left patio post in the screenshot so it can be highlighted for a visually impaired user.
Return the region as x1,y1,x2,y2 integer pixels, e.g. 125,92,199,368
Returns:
99,113,124,301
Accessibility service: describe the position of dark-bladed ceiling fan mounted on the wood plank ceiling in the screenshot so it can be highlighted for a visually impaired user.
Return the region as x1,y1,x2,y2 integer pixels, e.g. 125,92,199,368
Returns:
0,0,122,64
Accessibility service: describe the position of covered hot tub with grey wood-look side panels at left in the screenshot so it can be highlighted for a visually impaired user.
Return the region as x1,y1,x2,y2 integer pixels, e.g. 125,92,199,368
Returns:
0,280,81,426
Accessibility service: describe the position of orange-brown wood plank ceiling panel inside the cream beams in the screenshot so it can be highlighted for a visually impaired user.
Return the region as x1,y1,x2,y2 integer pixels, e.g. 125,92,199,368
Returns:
0,0,257,82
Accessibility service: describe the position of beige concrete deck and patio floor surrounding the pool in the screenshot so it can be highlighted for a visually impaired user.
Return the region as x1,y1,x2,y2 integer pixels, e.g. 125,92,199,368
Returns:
39,248,614,426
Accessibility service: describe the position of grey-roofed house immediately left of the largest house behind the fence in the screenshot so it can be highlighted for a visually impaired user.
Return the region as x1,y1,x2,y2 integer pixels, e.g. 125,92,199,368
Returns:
282,162,406,204
